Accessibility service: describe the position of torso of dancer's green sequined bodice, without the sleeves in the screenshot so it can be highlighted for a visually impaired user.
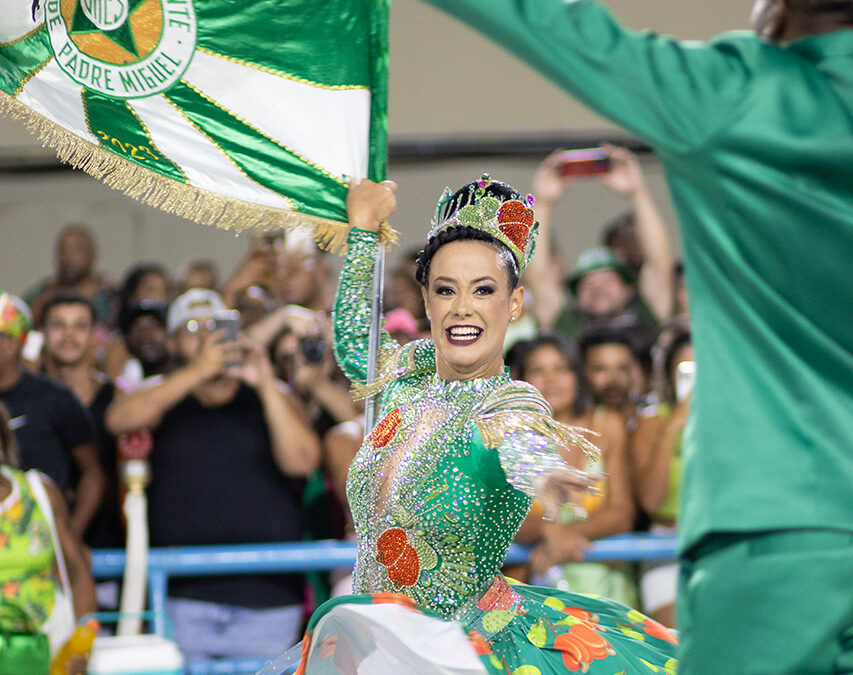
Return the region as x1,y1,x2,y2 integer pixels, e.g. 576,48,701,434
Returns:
347,375,530,616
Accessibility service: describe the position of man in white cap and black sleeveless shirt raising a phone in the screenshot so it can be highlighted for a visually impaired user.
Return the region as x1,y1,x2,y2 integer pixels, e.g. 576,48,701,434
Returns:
107,289,319,661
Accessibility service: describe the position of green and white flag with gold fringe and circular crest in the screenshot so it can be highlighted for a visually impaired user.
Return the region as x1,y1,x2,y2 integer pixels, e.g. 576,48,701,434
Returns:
0,0,389,243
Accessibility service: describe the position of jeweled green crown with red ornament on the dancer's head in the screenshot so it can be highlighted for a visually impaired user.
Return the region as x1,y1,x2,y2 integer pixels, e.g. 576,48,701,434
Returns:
427,173,539,276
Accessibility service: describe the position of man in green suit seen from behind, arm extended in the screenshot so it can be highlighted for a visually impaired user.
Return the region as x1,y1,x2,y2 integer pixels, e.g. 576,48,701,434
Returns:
428,0,853,675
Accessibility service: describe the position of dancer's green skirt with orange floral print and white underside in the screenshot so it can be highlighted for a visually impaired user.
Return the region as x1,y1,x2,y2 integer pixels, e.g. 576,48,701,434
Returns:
261,576,677,675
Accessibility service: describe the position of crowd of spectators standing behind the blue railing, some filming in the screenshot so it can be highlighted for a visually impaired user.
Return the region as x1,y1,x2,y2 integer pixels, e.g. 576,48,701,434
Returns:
0,148,694,659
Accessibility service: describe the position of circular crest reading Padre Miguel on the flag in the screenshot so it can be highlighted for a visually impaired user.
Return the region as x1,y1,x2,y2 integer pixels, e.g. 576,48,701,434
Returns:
44,0,196,99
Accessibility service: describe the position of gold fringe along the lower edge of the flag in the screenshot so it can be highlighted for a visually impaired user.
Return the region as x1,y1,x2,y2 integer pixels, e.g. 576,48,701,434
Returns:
0,91,399,252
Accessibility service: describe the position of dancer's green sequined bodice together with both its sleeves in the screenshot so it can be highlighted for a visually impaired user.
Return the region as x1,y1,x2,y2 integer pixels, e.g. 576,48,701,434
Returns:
334,230,571,617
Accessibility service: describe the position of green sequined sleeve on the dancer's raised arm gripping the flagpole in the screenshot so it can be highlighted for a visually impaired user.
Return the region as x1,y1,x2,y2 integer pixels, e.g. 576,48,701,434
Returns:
334,228,400,385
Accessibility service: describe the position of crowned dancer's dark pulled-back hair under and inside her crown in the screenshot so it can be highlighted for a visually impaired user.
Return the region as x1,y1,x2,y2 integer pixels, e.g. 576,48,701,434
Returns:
415,180,521,290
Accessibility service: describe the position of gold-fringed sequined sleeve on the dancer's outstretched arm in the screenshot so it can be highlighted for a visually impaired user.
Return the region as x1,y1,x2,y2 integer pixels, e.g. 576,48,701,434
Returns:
477,382,599,497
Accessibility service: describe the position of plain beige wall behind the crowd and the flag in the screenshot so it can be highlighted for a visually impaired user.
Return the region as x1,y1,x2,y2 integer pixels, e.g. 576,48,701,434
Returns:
0,0,749,292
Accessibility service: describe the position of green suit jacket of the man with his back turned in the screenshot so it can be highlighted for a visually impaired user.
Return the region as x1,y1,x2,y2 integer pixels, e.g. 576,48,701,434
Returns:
428,0,853,549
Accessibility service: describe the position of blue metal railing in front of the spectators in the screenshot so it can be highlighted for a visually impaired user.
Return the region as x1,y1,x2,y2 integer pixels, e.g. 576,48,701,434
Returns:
92,534,676,675
